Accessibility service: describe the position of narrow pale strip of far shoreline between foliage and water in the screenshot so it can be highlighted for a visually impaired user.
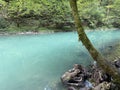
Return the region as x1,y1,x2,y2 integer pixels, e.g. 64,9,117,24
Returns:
0,27,119,35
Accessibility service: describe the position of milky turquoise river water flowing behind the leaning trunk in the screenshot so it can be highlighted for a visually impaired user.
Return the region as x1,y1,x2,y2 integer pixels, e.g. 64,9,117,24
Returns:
0,31,120,90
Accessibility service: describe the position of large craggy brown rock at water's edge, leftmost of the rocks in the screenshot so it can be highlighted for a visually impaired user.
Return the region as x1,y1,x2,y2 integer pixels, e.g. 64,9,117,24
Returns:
61,64,92,90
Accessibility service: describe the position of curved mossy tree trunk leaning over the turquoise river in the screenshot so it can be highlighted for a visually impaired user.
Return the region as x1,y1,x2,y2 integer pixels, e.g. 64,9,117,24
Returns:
70,0,120,84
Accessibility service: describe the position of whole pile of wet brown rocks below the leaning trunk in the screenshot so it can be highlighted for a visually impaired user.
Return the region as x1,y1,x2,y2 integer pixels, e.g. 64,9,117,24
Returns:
62,62,120,90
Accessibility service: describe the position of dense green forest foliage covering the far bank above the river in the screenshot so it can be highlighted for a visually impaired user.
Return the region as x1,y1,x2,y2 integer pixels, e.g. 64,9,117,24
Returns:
0,0,120,32
